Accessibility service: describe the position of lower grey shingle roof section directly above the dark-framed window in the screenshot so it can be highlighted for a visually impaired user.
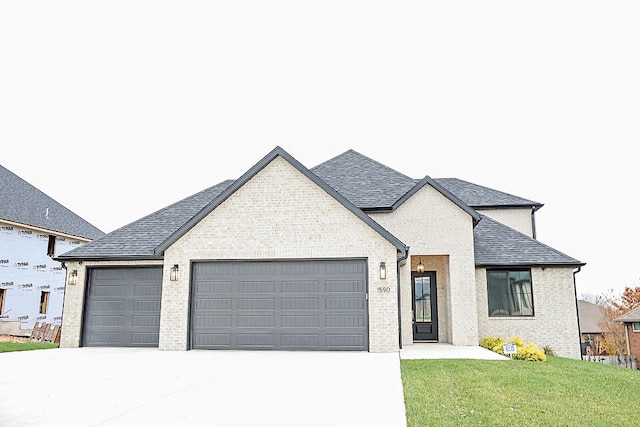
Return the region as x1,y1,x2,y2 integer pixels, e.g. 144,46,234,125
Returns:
473,215,585,267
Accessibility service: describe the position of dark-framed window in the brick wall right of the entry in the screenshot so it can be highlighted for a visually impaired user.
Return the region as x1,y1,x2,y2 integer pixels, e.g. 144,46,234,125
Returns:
487,270,533,317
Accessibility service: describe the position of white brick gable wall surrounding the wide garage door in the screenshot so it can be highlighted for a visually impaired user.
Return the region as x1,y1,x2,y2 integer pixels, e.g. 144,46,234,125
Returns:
160,157,398,352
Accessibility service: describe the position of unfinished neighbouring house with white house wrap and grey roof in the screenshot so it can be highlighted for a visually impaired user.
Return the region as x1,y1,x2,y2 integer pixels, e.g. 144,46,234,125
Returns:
0,166,104,335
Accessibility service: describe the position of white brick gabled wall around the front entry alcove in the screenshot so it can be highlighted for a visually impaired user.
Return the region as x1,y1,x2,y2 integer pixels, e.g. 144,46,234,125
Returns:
371,185,478,345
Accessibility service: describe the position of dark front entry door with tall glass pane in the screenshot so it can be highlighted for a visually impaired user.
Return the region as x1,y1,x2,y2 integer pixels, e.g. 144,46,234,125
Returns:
411,271,438,341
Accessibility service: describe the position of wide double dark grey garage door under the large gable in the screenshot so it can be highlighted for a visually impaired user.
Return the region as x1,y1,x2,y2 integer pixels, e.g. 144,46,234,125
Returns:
191,260,368,351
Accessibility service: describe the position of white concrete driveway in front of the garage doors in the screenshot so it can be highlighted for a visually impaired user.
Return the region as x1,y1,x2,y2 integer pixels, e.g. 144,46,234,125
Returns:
0,348,406,427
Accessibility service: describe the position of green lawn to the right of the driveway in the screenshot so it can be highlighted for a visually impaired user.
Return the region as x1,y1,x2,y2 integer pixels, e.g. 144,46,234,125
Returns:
401,356,640,427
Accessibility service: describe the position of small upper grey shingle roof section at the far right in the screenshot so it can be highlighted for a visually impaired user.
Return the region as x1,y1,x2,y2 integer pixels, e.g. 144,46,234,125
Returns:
436,178,542,208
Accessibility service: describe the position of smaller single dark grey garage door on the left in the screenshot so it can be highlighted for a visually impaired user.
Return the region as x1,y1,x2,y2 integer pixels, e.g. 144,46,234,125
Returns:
82,267,162,347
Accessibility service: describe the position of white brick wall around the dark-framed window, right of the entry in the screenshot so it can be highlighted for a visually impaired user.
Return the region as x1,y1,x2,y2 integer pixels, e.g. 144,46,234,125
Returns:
476,268,580,359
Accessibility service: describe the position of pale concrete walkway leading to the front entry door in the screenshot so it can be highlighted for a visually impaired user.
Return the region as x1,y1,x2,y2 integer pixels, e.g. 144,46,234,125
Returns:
400,343,510,360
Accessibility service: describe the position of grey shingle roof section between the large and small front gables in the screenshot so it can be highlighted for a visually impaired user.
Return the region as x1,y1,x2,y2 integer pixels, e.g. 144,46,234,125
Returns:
311,150,419,209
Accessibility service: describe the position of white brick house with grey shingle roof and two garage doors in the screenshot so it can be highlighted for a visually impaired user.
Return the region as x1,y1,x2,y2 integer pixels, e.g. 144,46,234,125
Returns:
57,147,584,359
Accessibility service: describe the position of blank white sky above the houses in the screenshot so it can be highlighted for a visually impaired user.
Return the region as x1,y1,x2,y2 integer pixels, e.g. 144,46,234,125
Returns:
0,0,640,300
